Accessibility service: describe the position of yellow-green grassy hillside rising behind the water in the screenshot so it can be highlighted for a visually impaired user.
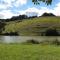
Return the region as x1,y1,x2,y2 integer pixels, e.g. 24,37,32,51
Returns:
4,17,60,35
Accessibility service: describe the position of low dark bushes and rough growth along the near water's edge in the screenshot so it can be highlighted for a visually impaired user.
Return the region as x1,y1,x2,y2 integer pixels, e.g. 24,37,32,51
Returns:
23,39,60,45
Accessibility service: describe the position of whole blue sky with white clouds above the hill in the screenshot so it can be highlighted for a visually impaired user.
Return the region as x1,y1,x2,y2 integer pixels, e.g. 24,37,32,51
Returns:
0,0,60,19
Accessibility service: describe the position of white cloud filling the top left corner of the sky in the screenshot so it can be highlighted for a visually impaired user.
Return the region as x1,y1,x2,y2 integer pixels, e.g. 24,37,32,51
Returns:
0,0,27,9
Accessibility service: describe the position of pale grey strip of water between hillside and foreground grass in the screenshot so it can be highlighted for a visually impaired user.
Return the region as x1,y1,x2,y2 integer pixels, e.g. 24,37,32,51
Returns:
0,36,60,43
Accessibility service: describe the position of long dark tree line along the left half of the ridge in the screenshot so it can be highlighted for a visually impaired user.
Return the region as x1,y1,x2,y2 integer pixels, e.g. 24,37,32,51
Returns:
0,15,37,22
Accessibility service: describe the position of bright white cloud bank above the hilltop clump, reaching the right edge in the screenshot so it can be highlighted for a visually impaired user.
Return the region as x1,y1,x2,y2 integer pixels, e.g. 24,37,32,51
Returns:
25,3,60,16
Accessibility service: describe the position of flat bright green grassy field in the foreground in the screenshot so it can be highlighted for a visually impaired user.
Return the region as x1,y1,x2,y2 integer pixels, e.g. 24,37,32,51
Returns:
0,44,60,60
